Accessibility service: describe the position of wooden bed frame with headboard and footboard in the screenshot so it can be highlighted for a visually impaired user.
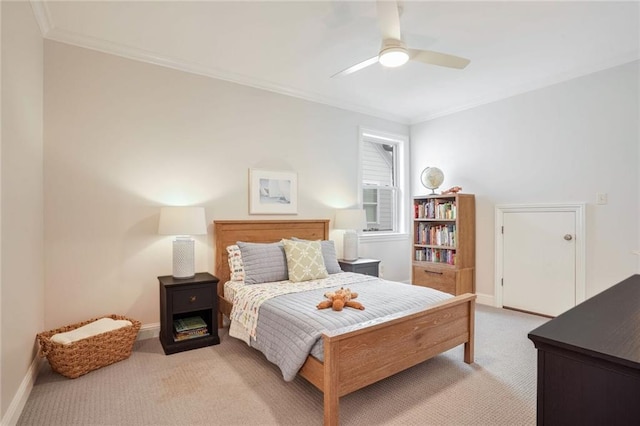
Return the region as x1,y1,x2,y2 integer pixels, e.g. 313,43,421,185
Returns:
213,219,476,425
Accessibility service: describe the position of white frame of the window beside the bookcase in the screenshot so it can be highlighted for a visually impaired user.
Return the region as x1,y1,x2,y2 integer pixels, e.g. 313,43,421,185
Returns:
358,127,409,241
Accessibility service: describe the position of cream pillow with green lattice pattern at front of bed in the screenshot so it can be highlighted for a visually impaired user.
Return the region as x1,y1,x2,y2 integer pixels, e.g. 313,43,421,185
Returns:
282,240,329,282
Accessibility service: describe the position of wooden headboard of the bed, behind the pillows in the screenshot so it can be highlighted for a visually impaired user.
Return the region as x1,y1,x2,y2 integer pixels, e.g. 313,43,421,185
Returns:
213,219,329,295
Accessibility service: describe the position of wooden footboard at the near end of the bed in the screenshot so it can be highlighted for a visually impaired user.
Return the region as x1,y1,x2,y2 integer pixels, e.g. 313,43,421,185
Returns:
300,294,476,425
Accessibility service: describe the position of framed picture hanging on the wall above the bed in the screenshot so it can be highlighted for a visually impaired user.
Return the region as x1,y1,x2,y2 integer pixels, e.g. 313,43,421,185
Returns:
249,169,298,214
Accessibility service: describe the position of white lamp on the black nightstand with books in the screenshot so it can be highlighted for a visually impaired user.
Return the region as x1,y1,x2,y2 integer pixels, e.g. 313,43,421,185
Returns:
158,207,207,279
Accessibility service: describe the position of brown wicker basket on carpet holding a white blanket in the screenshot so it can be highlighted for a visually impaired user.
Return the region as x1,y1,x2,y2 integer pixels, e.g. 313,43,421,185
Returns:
37,315,141,379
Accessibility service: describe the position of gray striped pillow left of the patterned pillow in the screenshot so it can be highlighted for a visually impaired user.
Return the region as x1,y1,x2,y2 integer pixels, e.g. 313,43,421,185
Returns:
237,241,289,284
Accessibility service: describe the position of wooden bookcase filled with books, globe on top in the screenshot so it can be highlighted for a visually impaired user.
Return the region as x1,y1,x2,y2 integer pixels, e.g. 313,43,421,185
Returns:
411,194,476,295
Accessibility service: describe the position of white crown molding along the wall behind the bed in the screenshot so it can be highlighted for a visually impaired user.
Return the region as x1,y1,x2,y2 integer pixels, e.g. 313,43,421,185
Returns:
42,26,409,125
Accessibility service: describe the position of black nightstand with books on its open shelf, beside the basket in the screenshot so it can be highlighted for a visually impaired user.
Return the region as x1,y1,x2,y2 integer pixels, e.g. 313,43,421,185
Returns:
158,272,220,355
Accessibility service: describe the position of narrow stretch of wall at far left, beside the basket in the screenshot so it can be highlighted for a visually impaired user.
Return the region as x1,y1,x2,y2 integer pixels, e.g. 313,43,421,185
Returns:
0,2,44,424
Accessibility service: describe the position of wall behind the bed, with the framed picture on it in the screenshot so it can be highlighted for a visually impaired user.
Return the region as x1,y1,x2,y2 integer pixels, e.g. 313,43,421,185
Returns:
44,41,408,328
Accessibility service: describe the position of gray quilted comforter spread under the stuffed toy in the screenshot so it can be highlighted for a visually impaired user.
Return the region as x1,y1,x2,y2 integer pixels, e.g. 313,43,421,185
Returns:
245,275,453,381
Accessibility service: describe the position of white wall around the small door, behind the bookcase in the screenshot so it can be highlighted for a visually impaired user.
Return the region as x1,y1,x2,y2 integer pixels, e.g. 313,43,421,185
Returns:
411,62,640,304
